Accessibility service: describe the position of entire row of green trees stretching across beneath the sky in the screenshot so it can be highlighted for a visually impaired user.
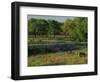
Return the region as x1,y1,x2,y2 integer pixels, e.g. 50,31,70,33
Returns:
28,17,88,41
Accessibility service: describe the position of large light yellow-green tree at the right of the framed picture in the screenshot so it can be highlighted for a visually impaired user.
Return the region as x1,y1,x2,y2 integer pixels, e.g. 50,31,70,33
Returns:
61,17,88,41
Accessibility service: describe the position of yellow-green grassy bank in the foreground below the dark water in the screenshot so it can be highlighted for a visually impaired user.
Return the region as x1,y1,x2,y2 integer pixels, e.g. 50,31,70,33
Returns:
28,49,88,66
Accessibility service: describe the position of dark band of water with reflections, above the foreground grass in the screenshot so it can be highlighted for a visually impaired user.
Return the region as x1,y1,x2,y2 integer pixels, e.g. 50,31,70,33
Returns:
28,43,87,54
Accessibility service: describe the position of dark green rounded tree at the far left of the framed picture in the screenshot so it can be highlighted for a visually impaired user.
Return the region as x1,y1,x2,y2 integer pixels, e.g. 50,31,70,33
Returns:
28,18,48,37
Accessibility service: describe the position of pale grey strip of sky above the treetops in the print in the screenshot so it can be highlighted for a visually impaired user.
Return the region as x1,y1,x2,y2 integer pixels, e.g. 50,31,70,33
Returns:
28,15,75,22
